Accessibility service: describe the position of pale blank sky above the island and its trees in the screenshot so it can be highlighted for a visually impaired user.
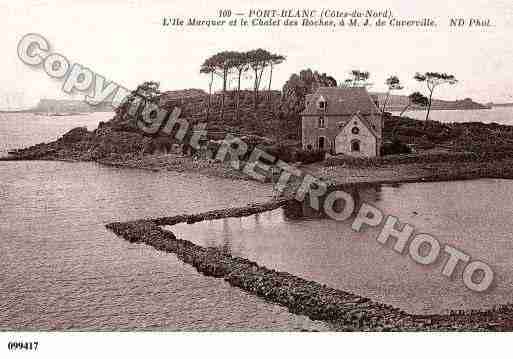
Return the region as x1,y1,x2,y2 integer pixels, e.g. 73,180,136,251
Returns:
0,0,513,109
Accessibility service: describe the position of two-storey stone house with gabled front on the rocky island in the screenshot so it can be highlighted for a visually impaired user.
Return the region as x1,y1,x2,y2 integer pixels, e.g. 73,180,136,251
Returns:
301,87,383,157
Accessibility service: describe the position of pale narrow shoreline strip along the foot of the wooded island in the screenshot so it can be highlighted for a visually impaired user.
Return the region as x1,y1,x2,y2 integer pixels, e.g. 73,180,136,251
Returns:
5,150,513,187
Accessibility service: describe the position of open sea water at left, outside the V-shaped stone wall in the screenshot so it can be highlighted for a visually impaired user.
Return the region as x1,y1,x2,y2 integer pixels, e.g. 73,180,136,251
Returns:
0,113,327,330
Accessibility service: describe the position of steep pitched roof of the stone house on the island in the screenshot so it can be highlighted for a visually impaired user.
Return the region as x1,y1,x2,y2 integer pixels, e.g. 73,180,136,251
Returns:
301,87,379,116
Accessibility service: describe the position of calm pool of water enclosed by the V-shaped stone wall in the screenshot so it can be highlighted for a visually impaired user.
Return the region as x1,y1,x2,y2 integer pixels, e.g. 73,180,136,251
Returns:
170,179,513,313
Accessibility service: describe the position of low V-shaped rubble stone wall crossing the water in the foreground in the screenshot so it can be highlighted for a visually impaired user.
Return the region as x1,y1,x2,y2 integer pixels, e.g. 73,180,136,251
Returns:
106,200,513,331
